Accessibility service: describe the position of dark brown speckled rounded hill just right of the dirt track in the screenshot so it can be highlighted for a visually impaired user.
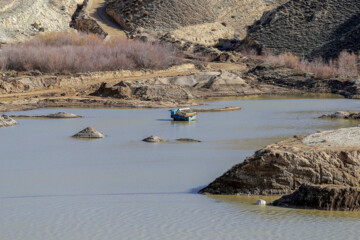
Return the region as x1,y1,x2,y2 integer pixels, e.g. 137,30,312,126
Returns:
106,0,218,31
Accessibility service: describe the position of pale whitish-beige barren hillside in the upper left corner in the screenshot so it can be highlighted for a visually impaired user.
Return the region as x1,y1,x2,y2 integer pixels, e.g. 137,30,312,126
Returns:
0,0,83,43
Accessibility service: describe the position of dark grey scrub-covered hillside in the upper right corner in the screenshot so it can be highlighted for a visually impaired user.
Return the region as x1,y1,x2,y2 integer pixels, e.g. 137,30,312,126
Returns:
248,0,360,58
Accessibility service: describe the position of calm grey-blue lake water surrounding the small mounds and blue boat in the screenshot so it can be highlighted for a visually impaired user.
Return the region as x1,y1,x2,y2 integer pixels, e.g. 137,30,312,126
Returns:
0,96,360,240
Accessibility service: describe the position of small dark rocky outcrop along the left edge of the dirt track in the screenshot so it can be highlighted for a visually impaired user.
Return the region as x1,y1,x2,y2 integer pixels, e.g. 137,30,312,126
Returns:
70,0,108,39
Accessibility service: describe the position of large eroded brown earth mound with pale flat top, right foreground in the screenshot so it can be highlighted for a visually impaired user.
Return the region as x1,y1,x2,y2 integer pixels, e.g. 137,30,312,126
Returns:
200,127,360,195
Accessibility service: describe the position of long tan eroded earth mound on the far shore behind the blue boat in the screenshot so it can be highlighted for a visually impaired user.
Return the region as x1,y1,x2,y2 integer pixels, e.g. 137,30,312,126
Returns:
92,71,251,101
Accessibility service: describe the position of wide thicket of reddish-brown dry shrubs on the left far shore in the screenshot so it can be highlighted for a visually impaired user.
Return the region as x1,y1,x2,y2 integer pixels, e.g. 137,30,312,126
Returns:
0,32,179,73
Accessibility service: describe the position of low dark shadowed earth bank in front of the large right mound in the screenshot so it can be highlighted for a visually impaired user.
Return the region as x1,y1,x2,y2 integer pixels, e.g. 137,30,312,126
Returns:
271,184,360,211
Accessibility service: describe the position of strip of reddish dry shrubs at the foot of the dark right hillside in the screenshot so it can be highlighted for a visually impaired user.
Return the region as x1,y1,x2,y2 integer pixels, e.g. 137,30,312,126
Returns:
242,50,359,79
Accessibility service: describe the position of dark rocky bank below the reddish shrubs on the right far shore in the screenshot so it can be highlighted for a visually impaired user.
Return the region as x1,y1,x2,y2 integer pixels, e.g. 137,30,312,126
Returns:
248,65,360,99
